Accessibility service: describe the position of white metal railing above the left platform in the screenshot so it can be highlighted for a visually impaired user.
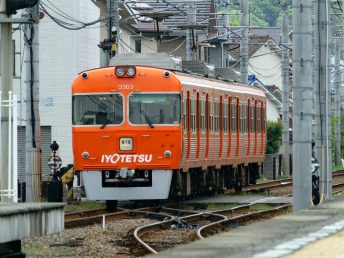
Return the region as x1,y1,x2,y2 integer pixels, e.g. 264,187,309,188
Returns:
0,91,18,203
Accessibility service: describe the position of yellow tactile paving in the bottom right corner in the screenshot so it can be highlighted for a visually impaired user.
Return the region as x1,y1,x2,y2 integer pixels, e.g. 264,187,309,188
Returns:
284,230,344,258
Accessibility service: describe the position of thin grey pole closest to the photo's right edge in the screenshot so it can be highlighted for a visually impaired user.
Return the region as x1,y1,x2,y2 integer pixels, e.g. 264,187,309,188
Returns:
334,39,341,166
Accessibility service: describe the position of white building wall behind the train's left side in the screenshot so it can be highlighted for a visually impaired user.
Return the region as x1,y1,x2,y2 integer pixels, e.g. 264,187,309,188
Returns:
14,0,99,165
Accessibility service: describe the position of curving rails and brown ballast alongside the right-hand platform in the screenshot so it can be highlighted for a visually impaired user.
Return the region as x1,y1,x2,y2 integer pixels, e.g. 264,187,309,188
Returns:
131,203,291,256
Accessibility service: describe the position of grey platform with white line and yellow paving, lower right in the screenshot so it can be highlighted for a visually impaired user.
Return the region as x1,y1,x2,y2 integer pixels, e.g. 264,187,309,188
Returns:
154,196,344,258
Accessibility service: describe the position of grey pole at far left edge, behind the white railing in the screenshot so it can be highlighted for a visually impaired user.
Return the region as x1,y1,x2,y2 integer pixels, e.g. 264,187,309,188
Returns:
0,0,13,202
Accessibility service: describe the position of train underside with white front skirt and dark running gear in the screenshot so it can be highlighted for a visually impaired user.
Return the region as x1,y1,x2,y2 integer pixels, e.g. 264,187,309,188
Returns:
81,163,260,211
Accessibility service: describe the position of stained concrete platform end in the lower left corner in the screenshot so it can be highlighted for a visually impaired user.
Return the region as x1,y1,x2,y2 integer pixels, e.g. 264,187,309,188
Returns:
0,203,64,257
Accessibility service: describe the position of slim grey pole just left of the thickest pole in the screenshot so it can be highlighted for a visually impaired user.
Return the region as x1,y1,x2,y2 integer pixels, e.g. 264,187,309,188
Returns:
282,2,290,176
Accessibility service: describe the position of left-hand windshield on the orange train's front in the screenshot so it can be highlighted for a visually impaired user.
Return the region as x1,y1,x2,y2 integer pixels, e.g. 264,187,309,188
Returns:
73,94,123,126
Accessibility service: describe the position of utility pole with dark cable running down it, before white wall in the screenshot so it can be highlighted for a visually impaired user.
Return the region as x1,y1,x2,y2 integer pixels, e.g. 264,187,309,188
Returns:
24,1,42,202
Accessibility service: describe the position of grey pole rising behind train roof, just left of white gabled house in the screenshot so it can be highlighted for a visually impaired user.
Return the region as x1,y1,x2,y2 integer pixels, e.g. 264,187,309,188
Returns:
240,0,249,84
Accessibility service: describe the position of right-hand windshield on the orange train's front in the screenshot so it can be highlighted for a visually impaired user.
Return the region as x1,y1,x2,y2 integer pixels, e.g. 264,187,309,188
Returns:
129,93,180,125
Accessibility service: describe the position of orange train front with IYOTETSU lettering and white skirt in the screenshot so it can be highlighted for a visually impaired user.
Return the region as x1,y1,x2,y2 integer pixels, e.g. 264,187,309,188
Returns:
72,66,182,200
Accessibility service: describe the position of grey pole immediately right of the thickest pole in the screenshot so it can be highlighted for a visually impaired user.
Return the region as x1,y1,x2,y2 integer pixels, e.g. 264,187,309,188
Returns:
314,0,332,198
